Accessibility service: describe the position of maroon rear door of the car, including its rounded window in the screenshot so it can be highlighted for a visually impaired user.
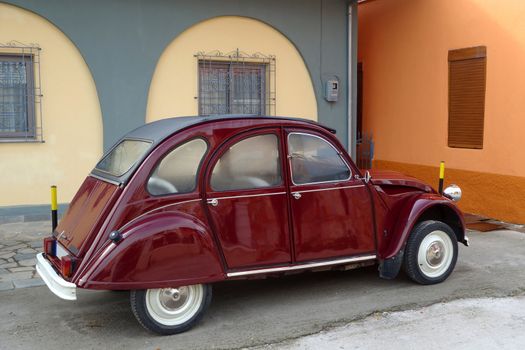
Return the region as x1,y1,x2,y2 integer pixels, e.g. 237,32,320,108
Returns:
206,129,291,269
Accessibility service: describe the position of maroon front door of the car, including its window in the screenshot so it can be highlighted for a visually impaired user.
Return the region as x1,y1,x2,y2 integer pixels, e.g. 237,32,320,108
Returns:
286,129,375,262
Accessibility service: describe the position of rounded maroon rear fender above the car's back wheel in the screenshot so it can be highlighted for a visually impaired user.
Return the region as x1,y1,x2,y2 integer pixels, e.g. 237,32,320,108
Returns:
76,211,225,289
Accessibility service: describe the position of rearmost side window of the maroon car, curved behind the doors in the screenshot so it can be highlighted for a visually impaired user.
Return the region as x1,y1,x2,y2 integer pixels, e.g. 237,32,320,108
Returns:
147,139,208,196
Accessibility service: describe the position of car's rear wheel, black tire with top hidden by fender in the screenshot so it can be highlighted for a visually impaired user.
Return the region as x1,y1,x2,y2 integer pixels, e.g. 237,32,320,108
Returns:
130,284,212,335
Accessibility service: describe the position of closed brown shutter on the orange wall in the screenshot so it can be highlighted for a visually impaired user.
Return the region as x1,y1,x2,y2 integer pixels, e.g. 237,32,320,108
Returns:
448,46,487,149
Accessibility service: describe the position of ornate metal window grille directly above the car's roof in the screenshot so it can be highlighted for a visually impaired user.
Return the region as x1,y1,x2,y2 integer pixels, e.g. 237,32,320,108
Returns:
195,50,276,115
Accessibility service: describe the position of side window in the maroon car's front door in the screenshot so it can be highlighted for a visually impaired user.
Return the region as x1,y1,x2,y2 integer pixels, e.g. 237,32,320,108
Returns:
288,133,351,185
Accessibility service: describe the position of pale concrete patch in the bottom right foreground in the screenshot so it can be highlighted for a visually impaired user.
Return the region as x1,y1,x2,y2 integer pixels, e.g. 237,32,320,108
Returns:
260,296,525,350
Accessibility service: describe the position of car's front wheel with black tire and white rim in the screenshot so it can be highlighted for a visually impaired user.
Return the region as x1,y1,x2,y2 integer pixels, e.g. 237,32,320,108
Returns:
403,220,458,284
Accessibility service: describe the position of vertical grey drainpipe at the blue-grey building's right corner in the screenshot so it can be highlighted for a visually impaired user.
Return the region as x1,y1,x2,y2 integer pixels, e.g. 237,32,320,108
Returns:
347,0,357,160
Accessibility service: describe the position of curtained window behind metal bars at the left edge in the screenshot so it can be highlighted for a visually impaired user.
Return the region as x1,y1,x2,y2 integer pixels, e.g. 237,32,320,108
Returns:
0,54,36,139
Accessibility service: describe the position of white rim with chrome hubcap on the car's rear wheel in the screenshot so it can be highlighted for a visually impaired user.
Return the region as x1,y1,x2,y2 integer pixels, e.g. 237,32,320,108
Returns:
146,284,204,326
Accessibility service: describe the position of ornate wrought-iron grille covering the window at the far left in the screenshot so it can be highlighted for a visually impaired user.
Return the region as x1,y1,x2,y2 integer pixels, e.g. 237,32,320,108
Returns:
0,41,42,142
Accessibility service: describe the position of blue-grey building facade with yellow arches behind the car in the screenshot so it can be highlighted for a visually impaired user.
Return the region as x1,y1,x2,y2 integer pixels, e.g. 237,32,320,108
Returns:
0,0,357,216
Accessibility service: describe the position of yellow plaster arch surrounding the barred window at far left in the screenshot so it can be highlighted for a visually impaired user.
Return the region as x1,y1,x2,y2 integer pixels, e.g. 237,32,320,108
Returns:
0,3,102,206
